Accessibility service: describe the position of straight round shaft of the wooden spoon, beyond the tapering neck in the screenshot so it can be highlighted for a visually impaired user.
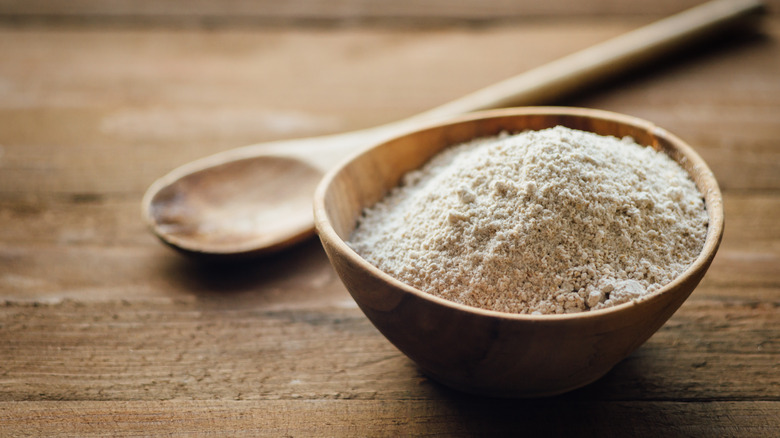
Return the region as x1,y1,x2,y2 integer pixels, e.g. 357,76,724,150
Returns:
407,0,765,122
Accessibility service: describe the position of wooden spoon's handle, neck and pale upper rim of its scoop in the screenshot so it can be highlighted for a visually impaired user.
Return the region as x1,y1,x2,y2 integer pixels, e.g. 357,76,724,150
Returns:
197,0,764,168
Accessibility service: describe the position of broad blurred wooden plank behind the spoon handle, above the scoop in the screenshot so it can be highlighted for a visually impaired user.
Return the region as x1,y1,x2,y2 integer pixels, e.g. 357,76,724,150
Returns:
0,20,780,194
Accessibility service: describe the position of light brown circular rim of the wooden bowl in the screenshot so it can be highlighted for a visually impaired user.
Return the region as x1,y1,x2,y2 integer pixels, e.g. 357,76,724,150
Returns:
314,106,725,322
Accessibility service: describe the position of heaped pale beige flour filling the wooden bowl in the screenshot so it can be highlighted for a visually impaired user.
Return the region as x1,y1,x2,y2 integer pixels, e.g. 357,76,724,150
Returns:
349,126,708,314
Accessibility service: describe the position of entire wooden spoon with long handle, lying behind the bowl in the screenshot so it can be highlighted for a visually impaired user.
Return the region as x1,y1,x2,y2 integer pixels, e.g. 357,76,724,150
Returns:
142,0,764,258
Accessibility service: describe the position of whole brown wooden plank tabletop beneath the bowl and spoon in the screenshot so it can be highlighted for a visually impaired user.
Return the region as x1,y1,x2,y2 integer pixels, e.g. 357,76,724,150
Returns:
0,0,780,436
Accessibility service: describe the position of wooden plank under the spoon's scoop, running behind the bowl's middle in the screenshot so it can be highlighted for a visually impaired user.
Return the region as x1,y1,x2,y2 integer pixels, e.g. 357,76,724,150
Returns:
0,192,780,302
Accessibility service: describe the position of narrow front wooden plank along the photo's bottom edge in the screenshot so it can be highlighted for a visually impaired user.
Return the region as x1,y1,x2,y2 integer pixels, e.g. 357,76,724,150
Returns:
0,400,780,437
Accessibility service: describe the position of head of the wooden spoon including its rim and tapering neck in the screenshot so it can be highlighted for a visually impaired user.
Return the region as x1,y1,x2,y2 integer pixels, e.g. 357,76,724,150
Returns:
141,124,404,260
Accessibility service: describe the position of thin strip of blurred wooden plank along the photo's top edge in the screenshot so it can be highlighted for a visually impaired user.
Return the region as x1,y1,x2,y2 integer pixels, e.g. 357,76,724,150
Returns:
0,0,777,25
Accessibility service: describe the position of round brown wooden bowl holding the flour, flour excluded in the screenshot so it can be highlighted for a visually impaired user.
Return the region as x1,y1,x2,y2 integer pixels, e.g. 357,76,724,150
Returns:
314,107,723,397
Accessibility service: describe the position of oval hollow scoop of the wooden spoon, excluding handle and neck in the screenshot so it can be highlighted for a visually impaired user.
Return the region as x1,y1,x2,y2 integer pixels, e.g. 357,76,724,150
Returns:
147,156,322,256
